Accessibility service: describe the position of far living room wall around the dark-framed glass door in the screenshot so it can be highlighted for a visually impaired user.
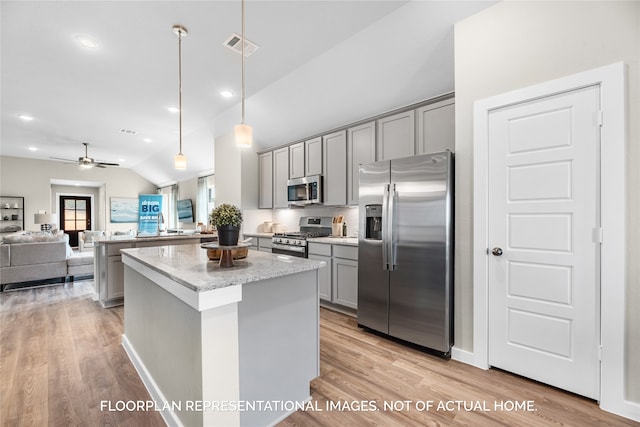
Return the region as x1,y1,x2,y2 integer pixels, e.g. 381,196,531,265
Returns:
0,156,156,231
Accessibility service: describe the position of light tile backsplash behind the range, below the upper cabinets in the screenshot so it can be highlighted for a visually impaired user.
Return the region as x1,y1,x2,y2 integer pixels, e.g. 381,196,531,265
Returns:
242,206,358,237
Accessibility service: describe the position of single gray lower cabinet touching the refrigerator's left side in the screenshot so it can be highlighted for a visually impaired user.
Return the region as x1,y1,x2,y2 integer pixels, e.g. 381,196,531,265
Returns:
331,245,358,309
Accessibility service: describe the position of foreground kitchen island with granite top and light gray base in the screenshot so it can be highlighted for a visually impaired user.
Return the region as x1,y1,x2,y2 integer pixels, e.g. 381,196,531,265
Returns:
122,245,325,426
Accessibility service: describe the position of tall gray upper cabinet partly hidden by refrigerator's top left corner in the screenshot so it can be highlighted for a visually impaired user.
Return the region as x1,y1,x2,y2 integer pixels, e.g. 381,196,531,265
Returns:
347,122,376,205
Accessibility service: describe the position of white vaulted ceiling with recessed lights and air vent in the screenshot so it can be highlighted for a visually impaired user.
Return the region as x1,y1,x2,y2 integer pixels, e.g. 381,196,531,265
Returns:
0,0,494,185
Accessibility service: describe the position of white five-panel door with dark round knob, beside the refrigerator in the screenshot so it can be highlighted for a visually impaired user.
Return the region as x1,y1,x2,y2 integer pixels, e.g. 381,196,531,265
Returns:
488,86,601,398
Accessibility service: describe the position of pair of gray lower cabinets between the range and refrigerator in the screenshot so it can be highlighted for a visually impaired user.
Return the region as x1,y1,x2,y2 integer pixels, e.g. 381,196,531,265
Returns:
309,242,358,309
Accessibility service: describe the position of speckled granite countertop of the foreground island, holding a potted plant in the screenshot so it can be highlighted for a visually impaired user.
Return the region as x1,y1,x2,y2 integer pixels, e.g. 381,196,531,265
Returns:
121,244,326,292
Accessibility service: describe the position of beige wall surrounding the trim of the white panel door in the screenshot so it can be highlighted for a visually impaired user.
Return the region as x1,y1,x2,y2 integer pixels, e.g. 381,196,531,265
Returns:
455,1,640,402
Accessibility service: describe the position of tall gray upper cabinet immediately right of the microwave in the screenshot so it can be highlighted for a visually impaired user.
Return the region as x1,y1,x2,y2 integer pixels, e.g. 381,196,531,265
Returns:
322,130,347,206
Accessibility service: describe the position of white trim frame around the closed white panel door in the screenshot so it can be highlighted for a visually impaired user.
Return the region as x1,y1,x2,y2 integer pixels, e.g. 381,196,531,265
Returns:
471,62,637,417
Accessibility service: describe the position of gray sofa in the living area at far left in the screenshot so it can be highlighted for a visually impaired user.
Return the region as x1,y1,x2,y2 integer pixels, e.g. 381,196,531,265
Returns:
0,234,93,290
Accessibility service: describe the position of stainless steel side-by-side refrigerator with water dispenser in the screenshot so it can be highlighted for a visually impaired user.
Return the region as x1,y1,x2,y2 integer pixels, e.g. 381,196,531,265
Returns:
358,151,453,356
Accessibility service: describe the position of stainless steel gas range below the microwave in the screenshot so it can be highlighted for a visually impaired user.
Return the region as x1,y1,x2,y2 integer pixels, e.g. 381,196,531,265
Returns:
271,216,333,258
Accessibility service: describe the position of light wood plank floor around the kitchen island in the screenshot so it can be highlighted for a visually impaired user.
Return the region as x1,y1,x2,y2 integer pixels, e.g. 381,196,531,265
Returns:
0,281,640,427
